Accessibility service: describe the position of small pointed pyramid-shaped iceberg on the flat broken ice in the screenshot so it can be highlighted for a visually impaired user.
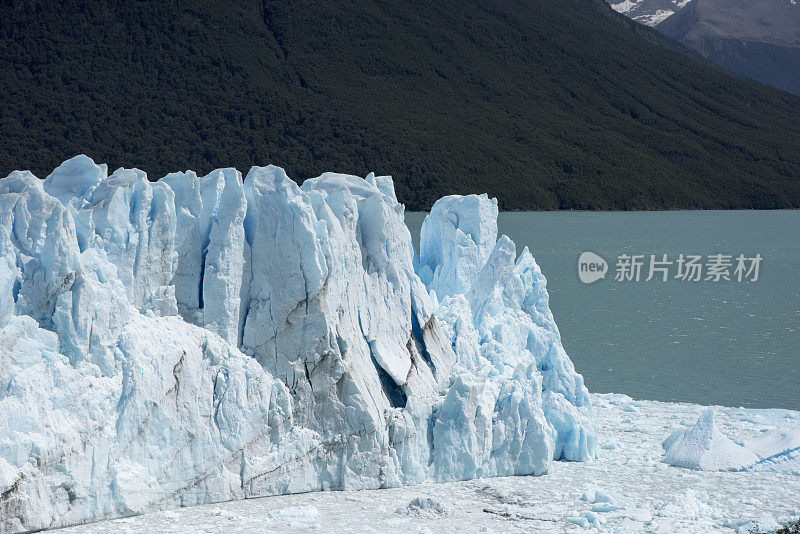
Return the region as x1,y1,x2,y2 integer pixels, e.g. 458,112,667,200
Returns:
664,409,758,471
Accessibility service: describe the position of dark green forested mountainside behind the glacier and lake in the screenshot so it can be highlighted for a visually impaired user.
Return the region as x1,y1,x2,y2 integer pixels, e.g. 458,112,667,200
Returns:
0,0,800,210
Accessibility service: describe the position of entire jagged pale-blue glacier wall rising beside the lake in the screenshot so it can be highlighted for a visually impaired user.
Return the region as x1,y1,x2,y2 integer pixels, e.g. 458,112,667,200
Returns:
0,156,596,532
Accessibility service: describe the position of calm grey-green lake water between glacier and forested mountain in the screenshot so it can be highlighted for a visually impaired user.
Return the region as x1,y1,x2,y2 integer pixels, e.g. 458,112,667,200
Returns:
406,211,800,409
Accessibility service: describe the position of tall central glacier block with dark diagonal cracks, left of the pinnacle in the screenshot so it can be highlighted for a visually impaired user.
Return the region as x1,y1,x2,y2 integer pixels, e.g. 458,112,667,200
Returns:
242,167,453,494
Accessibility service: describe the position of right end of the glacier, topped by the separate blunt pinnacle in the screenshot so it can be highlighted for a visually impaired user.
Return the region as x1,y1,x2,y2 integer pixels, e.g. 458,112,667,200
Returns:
418,195,597,462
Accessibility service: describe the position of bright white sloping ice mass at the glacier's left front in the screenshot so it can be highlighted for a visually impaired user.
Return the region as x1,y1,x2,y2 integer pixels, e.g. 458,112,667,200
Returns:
0,174,300,531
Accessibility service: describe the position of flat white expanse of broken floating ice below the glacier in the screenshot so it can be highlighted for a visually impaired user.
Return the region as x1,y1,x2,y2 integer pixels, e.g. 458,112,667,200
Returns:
57,394,800,534
